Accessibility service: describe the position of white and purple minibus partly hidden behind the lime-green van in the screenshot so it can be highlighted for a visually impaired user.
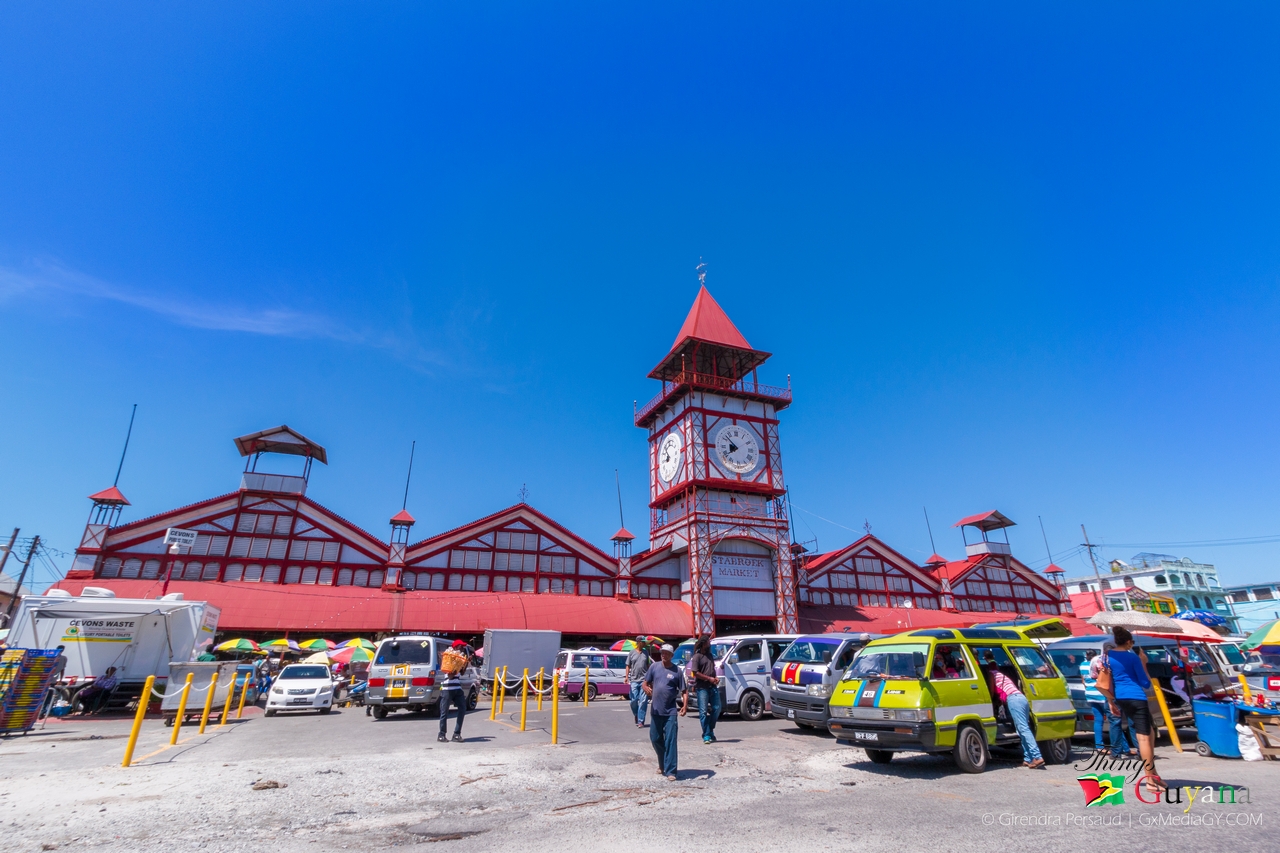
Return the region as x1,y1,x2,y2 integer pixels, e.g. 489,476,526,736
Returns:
769,633,884,729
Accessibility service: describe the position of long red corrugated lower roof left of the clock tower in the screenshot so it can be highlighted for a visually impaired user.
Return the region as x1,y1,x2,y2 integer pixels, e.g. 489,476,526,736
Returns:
45,578,694,638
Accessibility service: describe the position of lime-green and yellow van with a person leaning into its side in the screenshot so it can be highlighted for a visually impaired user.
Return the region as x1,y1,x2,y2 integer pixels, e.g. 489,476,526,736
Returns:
827,628,1075,774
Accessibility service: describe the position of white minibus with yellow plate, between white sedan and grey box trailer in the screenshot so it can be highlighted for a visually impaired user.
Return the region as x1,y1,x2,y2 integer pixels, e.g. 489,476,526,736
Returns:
365,635,480,720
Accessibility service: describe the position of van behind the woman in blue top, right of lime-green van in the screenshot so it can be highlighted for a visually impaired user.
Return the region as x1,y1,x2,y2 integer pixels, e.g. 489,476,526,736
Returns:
1046,634,1235,733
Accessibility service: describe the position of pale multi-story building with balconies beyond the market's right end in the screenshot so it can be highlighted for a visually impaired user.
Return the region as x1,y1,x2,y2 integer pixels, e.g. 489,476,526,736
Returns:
1066,553,1235,621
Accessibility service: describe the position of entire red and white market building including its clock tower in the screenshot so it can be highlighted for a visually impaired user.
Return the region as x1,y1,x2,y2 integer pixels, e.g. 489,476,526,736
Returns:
55,287,1070,639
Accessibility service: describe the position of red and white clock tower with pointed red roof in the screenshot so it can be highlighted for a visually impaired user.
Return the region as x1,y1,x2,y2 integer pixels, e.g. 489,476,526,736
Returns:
635,273,799,634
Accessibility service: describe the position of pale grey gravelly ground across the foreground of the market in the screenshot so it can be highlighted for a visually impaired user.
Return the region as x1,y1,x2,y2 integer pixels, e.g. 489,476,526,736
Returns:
0,701,1280,853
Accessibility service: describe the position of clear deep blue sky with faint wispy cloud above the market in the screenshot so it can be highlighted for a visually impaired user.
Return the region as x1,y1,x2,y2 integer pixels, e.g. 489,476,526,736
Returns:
0,3,1280,591
